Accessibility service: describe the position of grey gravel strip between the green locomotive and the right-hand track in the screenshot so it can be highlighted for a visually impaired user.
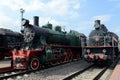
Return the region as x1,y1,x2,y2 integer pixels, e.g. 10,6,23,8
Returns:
21,60,91,80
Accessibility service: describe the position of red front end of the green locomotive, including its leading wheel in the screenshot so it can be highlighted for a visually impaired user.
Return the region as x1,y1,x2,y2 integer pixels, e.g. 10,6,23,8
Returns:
12,50,42,70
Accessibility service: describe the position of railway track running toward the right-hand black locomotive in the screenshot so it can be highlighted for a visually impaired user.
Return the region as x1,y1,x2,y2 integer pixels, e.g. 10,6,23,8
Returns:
63,57,119,80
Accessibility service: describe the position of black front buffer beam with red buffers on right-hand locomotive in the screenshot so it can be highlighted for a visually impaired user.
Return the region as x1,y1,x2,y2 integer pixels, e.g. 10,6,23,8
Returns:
83,46,118,64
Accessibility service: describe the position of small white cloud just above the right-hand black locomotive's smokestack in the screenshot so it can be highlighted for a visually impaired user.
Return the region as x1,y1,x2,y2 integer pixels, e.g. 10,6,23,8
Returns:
92,15,112,22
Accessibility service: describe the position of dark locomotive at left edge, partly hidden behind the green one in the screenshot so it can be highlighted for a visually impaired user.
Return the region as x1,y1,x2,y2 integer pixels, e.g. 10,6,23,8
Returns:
0,28,22,60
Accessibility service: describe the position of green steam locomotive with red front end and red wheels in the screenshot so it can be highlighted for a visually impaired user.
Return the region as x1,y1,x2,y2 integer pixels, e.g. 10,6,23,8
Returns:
12,16,86,70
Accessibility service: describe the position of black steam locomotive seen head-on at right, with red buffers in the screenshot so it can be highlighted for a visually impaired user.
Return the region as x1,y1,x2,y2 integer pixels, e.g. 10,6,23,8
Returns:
83,20,119,64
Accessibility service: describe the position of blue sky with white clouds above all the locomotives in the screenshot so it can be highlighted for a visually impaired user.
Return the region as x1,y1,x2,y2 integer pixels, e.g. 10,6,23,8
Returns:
0,0,120,37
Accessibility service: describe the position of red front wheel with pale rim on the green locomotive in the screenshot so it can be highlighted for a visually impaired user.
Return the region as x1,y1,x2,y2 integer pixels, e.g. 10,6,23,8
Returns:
30,57,40,70
